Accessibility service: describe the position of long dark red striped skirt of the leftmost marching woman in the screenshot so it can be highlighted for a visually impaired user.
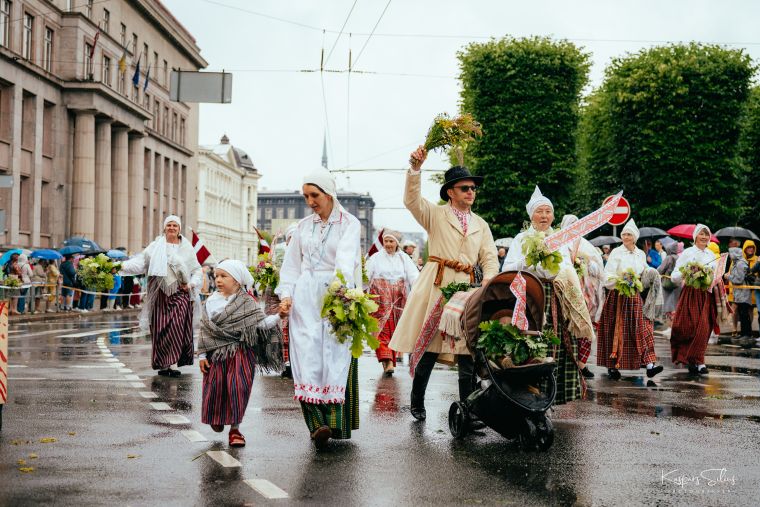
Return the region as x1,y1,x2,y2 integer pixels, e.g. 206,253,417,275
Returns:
148,277,193,370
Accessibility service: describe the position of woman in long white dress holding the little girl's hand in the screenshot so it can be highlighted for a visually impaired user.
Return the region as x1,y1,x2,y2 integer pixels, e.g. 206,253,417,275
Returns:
275,170,361,448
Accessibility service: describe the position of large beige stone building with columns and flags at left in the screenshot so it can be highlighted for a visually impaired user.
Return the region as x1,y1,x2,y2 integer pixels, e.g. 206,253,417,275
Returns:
0,0,207,251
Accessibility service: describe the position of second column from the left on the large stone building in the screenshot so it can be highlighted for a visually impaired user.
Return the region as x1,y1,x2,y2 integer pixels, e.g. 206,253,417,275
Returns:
95,119,112,248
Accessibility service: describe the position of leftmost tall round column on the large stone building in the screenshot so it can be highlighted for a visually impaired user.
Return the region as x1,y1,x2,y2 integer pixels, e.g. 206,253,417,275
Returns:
71,111,95,238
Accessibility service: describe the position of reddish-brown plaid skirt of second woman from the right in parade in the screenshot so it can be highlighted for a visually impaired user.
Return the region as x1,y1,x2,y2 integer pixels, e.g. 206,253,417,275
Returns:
596,290,657,370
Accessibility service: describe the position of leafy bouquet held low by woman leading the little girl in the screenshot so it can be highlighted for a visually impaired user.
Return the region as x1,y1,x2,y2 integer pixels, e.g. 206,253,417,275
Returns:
322,271,380,358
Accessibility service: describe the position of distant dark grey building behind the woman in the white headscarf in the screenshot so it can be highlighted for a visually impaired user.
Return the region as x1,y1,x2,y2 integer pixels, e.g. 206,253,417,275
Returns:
258,190,375,252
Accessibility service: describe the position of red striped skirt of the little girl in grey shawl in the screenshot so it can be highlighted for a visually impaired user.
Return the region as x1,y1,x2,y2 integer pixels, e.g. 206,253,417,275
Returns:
201,347,256,425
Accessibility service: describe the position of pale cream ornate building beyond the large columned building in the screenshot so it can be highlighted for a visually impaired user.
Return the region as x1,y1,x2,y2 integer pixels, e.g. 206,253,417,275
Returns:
196,135,261,265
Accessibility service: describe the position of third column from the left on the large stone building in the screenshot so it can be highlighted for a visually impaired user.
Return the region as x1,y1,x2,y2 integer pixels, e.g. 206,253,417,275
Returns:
110,127,129,248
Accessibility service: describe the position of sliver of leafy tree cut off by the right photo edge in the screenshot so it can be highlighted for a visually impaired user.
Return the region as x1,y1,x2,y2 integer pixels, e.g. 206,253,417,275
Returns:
739,88,760,233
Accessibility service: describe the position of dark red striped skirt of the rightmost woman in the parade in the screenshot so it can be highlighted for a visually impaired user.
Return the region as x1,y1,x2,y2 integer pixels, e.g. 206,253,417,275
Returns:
670,287,719,365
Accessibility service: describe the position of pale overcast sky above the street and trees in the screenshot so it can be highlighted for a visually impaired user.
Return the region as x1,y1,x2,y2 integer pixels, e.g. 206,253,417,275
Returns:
163,0,760,238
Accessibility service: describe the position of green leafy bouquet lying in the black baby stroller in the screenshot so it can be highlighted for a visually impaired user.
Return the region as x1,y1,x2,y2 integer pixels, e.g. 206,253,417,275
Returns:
477,320,560,368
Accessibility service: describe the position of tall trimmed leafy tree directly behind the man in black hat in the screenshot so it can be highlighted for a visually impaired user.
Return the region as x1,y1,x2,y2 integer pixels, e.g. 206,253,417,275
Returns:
458,37,589,237
